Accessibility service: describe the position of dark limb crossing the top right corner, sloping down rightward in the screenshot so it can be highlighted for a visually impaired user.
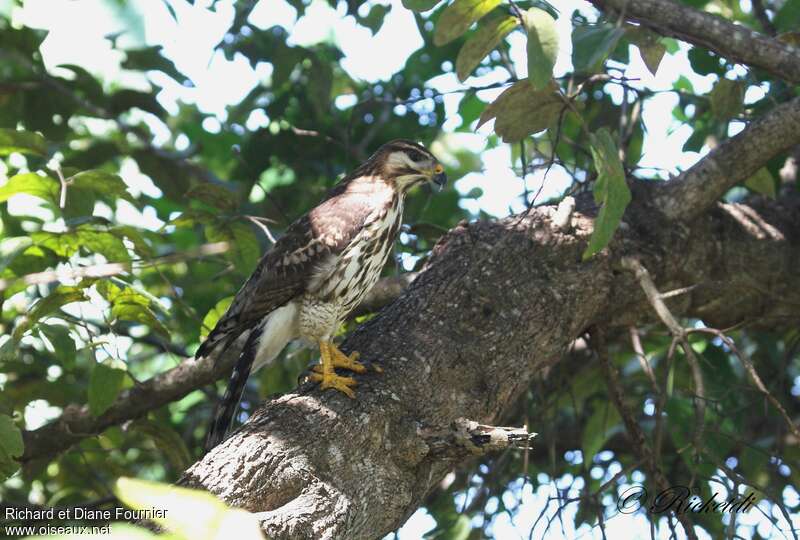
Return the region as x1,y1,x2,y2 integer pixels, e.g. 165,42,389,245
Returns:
590,0,800,84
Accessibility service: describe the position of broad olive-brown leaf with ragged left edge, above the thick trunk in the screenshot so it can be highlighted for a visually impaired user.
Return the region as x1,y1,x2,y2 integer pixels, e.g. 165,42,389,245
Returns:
476,79,565,143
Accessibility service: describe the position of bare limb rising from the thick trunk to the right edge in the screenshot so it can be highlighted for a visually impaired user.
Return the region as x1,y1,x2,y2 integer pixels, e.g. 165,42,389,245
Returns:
655,97,800,220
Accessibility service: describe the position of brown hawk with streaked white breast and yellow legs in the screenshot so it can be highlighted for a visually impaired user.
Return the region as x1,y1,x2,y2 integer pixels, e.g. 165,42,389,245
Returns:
196,140,446,449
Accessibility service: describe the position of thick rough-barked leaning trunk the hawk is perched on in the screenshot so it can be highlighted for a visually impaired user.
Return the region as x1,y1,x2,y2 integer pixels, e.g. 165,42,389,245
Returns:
182,183,800,538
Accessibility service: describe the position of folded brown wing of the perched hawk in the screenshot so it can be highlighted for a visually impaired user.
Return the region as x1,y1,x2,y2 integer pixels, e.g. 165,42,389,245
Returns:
196,185,372,357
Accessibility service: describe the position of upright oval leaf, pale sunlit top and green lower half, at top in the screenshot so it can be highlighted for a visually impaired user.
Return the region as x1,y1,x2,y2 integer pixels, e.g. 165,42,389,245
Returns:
522,8,558,90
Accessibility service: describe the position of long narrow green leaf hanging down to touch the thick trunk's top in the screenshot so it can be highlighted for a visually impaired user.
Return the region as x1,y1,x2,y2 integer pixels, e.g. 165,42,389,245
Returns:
583,128,631,260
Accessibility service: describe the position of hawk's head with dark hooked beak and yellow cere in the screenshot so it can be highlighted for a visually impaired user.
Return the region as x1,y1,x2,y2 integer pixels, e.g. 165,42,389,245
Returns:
371,139,447,191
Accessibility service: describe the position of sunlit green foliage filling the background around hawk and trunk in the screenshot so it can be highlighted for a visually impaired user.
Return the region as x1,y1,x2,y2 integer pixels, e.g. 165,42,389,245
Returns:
0,0,800,538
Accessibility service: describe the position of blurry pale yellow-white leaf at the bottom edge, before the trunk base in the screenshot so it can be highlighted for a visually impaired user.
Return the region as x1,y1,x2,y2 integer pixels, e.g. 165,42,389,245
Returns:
114,478,264,540
